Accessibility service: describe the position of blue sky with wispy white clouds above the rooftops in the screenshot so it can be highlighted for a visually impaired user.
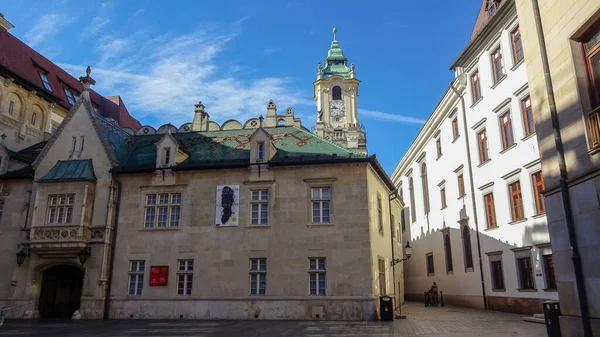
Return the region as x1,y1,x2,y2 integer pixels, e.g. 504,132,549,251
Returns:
0,0,481,173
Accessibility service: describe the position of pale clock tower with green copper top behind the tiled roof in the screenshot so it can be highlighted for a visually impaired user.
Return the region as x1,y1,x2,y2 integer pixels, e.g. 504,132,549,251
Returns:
313,27,367,154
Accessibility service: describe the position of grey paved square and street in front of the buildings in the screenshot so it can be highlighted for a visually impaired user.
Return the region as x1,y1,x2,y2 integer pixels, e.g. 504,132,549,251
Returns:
0,303,546,337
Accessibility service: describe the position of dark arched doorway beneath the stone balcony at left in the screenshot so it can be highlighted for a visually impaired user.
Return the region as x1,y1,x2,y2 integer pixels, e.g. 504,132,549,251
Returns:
39,265,83,318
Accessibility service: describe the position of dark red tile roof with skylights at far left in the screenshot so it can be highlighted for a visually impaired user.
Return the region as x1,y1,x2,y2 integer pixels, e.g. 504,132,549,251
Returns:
0,29,142,131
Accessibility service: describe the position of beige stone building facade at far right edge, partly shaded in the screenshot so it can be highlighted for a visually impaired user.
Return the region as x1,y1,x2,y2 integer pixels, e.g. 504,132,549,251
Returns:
517,0,600,336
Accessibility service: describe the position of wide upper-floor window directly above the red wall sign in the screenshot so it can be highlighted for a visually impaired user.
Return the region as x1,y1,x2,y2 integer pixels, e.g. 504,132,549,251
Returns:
144,193,181,228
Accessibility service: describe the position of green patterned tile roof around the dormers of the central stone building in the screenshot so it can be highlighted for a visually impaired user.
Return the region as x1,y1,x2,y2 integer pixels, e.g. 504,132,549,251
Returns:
117,126,366,171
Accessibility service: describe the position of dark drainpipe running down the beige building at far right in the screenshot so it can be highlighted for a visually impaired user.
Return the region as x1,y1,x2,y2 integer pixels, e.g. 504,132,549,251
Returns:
531,0,592,337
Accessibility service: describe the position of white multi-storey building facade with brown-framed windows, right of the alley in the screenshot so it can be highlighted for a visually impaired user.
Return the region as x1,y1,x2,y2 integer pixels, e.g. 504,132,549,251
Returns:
392,1,558,314
